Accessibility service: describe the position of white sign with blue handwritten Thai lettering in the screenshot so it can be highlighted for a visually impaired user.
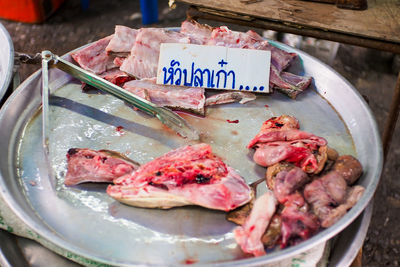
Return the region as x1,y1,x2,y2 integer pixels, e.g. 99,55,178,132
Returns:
157,43,271,93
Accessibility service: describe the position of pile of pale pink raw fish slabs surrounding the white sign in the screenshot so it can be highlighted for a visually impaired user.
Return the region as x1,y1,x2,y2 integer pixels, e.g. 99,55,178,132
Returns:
72,21,311,115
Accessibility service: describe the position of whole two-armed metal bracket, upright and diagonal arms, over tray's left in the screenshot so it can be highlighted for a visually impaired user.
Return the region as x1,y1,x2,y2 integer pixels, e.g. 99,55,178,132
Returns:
35,51,199,151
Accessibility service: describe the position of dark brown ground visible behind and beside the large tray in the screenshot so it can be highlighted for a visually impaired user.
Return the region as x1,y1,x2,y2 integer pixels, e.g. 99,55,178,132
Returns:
0,0,400,266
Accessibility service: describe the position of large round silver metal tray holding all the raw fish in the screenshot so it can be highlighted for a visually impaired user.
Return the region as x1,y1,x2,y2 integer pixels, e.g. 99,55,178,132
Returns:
0,35,382,266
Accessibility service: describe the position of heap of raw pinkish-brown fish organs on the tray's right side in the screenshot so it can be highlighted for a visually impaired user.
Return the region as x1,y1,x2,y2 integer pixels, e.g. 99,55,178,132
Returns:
227,115,364,256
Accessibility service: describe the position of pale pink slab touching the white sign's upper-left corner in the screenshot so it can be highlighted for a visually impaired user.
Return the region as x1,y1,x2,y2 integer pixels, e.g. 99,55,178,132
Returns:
120,28,190,79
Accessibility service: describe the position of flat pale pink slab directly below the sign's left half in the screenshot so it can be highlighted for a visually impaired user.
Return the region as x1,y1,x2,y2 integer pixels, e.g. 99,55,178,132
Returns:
123,78,205,116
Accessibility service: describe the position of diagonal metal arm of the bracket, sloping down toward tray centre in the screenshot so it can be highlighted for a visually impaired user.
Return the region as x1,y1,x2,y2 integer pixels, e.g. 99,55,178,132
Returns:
42,51,199,140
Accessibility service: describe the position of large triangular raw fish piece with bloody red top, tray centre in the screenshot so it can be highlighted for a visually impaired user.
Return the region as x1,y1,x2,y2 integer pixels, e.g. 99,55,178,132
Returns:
107,144,252,211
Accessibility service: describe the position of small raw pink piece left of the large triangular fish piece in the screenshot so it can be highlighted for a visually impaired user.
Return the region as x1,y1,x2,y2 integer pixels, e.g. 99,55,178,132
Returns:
64,148,139,186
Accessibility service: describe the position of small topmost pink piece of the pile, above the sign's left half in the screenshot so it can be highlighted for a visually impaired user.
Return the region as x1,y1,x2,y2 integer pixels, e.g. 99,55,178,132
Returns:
181,20,213,45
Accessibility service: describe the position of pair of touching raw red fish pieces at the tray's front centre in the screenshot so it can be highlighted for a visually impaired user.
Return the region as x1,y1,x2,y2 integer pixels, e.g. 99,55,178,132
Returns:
64,144,252,211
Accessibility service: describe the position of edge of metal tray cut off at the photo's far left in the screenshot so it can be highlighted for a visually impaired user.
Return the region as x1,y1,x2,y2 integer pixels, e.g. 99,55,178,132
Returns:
0,23,14,102
